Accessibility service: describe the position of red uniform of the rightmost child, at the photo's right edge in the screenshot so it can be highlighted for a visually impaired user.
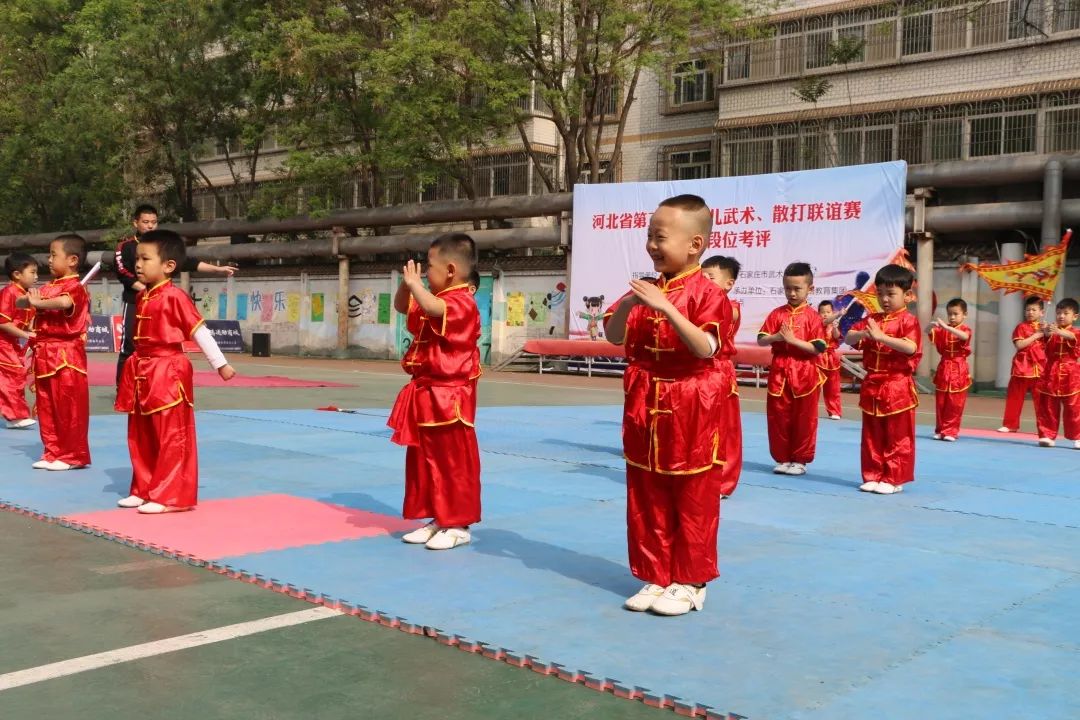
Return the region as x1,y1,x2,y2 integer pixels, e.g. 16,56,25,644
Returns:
1035,327,1080,440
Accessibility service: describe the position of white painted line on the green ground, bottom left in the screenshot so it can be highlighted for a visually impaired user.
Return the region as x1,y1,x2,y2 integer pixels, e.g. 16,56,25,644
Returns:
0,608,341,691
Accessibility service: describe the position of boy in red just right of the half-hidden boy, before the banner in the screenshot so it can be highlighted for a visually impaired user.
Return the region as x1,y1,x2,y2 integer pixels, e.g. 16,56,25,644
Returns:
757,262,827,475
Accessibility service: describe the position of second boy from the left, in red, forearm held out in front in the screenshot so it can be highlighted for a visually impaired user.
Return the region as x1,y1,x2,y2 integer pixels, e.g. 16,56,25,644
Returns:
15,233,90,471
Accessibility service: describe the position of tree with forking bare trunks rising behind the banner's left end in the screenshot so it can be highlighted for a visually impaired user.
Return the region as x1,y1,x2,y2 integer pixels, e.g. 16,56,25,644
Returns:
488,0,750,191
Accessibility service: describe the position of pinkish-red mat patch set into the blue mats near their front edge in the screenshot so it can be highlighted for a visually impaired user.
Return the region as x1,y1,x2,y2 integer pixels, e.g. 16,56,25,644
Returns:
63,494,420,560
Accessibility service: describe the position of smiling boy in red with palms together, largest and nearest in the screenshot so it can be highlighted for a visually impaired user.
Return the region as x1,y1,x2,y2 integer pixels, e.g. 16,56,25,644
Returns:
605,195,731,615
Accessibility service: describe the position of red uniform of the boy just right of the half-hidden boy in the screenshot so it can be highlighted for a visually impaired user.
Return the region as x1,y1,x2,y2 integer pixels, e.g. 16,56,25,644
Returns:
757,302,826,464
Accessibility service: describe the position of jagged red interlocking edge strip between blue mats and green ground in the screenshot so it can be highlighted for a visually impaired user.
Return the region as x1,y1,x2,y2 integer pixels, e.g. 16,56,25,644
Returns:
0,500,748,720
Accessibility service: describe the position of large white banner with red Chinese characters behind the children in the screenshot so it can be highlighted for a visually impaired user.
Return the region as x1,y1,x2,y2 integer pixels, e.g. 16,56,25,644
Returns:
569,162,907,343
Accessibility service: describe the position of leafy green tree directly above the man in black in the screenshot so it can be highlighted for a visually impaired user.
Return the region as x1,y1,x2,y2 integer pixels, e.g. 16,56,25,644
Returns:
75,0,281,220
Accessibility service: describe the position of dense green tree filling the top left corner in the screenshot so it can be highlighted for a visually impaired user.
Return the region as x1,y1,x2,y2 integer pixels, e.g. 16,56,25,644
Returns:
0,0,124,232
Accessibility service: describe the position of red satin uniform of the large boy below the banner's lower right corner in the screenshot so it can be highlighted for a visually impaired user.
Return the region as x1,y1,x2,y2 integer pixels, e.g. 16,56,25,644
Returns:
851,308,922,485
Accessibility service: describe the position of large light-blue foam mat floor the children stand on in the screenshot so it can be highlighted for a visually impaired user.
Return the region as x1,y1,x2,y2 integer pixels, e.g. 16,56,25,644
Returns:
0,406,1080,720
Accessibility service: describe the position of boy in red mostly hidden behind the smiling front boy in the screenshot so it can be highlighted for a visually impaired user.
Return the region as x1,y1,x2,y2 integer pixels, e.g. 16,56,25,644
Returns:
701,255,742,500
